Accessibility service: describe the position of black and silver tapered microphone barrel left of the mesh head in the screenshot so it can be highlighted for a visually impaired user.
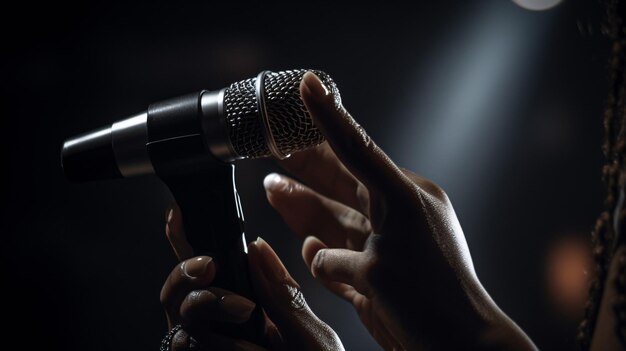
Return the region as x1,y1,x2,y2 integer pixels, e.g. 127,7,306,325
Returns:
62,90,229,182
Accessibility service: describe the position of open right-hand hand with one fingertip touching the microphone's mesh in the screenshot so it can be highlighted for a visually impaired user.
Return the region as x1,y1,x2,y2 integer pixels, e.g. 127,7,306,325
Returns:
264,73,535,350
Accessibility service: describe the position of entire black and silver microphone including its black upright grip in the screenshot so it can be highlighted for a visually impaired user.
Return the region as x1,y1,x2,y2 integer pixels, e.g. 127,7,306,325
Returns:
61,69,339,345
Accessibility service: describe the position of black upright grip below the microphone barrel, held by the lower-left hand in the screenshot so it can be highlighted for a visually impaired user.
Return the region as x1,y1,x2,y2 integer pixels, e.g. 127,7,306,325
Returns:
161,161,267,347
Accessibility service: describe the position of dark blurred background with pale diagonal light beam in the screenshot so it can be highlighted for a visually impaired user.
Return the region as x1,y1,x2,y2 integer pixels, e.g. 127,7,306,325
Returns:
0,0,608,350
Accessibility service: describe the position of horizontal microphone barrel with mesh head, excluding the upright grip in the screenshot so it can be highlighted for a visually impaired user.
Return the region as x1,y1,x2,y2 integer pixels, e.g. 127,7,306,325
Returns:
61,69,339,182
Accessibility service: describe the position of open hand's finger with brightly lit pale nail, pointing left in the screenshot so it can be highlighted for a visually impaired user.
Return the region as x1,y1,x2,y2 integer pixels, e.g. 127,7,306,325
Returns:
263,173,372,250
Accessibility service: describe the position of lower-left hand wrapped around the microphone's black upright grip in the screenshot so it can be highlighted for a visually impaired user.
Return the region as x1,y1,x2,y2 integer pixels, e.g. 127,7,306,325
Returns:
161,208,343,351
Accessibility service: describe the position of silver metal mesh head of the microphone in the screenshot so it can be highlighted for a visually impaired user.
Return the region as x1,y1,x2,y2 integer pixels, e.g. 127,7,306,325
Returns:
224,69,339,158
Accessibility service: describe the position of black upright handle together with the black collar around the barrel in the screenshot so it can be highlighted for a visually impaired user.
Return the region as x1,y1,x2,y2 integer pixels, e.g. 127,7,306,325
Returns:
139,91,266,346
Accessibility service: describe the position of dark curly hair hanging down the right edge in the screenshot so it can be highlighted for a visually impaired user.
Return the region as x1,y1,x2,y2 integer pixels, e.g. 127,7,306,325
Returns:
578,0,626,350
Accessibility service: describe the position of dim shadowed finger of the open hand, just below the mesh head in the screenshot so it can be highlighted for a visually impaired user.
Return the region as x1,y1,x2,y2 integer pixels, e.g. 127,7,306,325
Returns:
278,142,369,216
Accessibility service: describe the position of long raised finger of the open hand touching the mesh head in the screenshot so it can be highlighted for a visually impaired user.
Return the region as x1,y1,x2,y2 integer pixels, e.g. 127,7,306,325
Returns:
300,72,405,202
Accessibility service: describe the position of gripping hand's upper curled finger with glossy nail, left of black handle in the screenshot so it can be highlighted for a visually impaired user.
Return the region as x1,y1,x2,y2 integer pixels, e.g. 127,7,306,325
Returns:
160,256,215,327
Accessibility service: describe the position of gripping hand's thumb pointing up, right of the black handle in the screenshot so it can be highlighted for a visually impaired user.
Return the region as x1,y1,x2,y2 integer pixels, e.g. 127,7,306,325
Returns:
248,238,344,350
